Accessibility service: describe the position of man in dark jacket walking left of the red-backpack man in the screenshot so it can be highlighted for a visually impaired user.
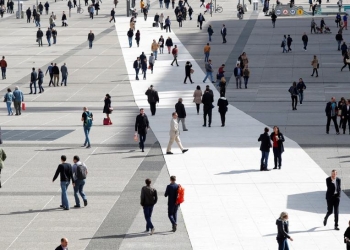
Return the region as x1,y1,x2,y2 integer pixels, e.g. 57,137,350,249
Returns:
140,178,157,235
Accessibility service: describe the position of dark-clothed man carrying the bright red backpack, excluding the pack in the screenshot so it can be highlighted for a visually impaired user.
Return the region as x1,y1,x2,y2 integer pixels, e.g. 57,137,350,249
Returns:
164,176,179,232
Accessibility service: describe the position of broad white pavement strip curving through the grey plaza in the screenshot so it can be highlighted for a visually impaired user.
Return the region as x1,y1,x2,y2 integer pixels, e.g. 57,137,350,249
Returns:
116,15,350,250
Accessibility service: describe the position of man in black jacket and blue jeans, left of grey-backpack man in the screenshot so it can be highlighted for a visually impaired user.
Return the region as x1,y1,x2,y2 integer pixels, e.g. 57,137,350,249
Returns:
52,155,74,210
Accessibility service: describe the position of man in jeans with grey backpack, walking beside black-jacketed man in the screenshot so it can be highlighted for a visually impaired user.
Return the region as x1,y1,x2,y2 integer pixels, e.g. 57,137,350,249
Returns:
72,155,88,208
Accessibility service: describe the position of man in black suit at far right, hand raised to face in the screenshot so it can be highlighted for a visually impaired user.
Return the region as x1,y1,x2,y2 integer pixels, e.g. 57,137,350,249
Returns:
323,169,341,230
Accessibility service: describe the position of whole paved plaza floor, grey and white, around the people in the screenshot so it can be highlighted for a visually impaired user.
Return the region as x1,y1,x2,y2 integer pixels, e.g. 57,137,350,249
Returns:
0,0,350,250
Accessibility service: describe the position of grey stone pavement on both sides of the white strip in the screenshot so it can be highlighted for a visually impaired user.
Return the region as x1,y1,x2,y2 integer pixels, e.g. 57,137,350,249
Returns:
0,0,350,249
